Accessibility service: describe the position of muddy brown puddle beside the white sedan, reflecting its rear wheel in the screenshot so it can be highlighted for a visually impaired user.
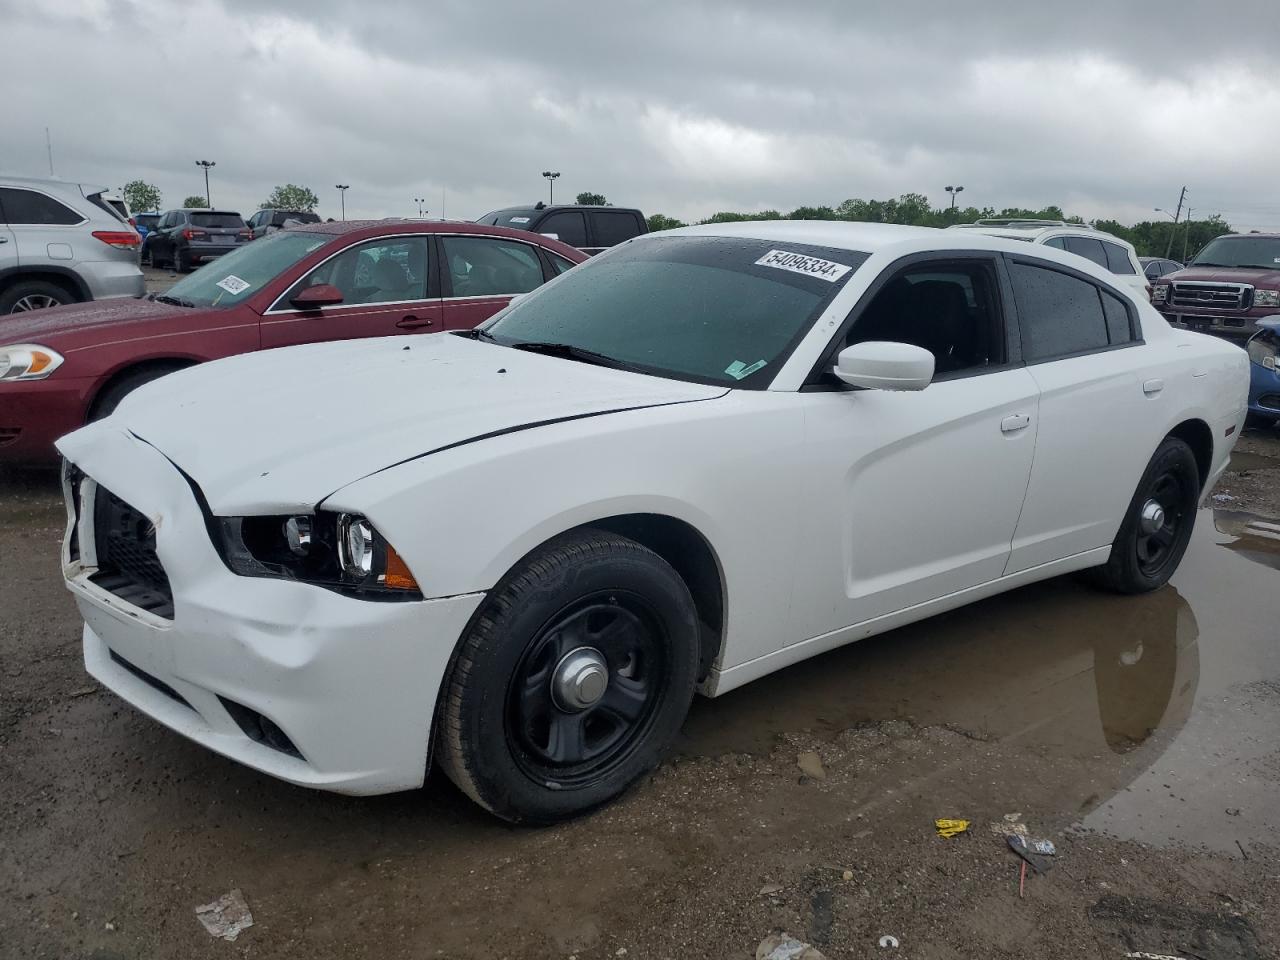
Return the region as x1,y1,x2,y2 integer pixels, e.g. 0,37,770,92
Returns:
681,511,1280,851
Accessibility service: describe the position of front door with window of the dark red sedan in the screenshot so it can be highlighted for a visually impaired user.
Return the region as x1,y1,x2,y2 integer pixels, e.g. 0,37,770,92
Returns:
261,234,444,349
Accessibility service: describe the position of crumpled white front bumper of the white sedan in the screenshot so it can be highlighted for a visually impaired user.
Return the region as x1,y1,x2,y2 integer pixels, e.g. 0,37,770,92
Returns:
59,424,484,794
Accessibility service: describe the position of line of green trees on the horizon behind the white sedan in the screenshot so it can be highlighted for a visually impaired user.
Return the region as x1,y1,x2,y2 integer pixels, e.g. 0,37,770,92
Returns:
649,193,1233,260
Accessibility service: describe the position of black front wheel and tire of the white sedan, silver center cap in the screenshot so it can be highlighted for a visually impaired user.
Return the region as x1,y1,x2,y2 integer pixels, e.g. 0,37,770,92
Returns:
439,530,698,823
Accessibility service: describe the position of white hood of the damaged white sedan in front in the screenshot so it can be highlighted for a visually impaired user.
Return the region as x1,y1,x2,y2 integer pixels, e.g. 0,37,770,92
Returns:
58,334,727,515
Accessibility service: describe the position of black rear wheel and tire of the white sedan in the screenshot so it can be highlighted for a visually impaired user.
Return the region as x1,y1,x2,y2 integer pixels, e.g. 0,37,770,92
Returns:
1096,436,1201,594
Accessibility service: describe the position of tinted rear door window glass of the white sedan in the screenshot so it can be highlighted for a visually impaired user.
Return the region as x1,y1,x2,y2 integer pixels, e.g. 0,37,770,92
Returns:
1009,261,1128,364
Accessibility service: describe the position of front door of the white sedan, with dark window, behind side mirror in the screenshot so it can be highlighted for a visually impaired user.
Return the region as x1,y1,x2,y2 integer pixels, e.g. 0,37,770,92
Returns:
795,255,1039,637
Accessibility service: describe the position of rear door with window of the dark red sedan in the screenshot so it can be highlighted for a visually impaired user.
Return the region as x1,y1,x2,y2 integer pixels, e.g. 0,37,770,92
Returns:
440,236,544,330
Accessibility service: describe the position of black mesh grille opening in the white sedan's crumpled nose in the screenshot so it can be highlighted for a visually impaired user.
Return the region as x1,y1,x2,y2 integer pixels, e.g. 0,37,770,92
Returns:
90,486,173,620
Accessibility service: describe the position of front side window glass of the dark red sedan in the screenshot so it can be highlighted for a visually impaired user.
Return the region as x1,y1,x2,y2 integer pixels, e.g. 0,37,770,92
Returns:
284,237,429,306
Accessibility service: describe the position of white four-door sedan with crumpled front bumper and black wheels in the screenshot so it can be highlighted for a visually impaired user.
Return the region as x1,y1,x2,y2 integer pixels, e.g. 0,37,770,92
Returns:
59,221,1249,822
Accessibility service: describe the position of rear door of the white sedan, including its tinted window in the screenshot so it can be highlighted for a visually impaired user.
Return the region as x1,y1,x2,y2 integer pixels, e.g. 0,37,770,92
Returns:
1006,256,1164,573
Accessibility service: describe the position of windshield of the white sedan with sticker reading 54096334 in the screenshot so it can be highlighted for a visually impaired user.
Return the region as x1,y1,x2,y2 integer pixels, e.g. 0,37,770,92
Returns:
485,237,868,389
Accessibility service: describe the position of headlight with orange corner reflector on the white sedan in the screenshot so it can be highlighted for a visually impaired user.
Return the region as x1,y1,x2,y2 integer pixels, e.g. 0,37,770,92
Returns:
212,511,422,600
